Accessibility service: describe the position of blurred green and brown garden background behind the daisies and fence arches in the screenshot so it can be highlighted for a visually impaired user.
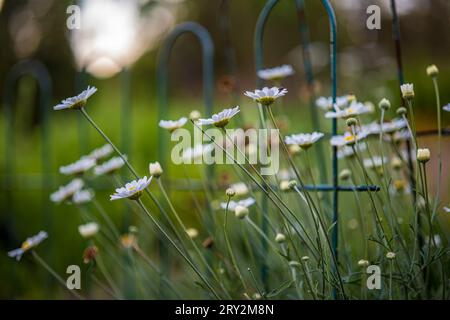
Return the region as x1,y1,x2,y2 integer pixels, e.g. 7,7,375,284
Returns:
0,0,450,299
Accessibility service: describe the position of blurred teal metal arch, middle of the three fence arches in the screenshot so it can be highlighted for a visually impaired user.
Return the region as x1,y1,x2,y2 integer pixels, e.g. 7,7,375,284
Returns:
157,22,214,170
